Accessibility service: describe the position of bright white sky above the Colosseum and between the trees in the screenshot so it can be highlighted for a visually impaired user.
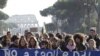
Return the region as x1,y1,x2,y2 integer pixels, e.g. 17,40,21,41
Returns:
3,0,57,26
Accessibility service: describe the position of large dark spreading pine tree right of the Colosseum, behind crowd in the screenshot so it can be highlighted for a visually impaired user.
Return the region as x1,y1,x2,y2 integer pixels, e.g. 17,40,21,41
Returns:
40,0,99,33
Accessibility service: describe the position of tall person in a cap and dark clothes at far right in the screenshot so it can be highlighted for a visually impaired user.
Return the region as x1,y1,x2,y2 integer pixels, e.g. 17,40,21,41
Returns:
87,27,100,48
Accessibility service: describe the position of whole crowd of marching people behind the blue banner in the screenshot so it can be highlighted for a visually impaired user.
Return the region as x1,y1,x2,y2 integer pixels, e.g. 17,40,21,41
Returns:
0,28,100,51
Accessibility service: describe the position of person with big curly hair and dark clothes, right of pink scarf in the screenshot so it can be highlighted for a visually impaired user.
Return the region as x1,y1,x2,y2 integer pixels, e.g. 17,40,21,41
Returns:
74,33,87,51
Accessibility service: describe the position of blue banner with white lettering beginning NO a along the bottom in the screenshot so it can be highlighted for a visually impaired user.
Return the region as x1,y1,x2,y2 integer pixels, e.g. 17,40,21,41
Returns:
0,49,100,56
